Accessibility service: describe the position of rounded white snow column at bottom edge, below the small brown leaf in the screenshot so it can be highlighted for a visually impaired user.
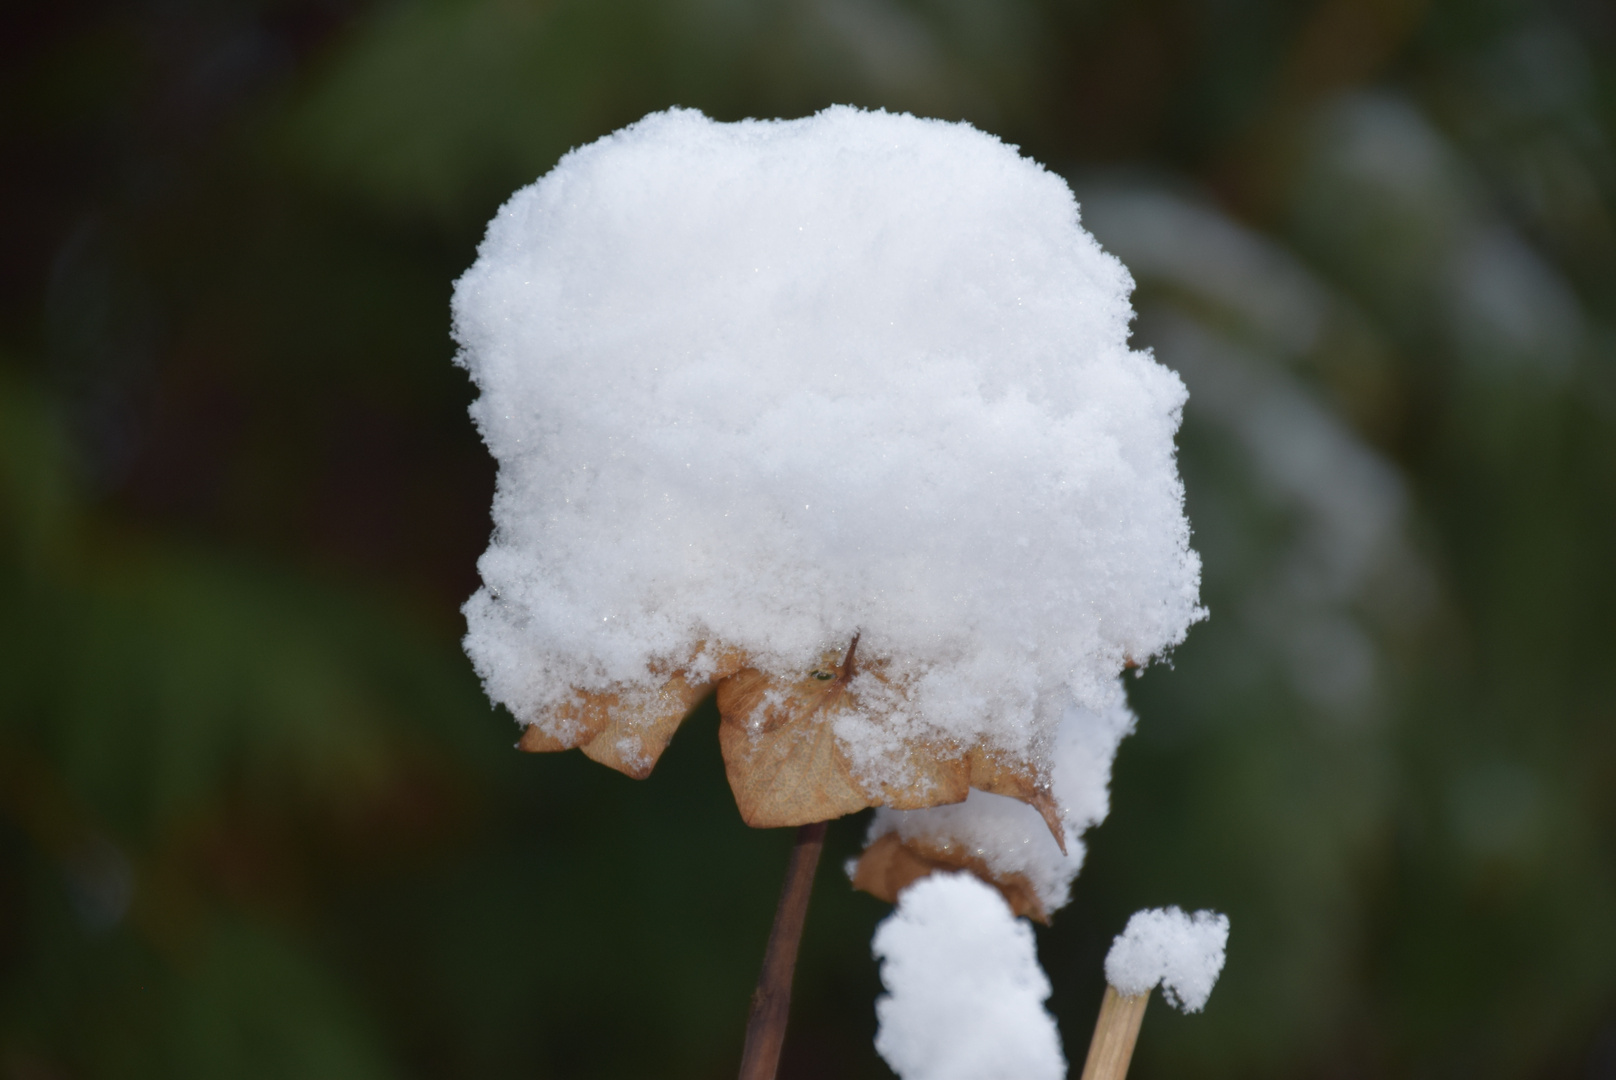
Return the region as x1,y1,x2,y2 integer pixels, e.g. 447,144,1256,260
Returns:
871,873,1067,1080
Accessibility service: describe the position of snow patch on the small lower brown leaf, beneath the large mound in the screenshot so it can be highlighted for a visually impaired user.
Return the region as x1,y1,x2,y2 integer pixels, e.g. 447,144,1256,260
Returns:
868,679,1134,912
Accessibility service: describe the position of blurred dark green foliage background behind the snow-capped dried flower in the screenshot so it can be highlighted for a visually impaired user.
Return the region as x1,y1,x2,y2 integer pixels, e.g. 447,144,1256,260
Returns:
0,0,1616,1080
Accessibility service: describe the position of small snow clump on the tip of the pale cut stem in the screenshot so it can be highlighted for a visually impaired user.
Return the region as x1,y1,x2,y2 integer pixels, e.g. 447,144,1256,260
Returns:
1105,907,1228,1012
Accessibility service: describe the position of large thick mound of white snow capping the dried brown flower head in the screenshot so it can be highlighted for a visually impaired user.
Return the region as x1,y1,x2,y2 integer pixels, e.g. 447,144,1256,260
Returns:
454,107,1201,785
